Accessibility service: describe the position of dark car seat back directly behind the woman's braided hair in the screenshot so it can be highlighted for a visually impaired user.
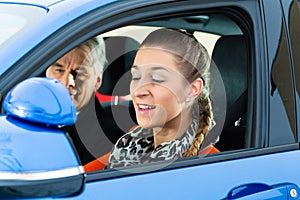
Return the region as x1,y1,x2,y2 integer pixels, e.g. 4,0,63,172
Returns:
204,35,248,151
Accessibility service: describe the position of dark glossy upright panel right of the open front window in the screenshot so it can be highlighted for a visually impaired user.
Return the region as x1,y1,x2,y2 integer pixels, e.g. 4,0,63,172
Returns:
265,1,297,146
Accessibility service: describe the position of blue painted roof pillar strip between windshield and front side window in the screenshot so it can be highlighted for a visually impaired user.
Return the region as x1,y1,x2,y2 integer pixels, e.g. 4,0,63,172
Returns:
0,0,114,76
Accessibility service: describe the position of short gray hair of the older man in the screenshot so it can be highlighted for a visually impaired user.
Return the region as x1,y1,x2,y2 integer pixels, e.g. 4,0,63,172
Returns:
79,36,107,75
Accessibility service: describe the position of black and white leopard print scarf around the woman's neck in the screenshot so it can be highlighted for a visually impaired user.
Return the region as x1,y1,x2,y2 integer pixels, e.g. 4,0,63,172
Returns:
108,115,199,168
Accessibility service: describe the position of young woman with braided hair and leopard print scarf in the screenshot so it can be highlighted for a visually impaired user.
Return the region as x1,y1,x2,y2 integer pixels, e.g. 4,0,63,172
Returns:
108,29,213,168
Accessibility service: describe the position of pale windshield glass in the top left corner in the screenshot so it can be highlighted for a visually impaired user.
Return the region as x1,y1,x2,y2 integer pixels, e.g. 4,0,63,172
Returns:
0,3,47,49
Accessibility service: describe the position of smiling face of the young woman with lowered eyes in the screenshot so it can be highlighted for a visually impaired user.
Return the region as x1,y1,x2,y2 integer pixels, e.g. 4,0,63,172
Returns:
130,48,190,128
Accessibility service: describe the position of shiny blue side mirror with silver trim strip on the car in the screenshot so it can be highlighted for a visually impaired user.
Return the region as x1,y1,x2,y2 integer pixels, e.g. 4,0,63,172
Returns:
0,78,84,198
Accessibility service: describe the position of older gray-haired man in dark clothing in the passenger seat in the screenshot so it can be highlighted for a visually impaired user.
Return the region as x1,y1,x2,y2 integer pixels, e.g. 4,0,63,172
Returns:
46,38,126,165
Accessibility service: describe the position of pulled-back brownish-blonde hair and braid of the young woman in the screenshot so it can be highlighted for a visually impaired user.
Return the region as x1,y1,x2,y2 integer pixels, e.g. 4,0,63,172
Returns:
140,28,213,157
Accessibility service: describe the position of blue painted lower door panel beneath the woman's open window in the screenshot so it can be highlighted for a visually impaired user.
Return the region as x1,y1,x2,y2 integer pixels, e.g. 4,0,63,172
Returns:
73,151,300,200
